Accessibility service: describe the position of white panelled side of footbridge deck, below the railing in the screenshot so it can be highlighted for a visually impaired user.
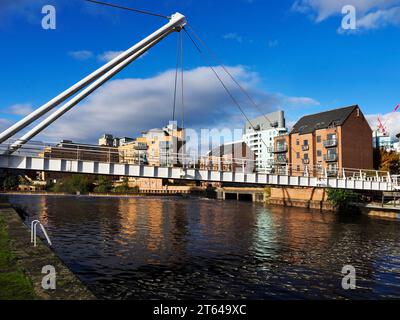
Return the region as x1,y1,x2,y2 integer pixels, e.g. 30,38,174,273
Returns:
0,155,395,191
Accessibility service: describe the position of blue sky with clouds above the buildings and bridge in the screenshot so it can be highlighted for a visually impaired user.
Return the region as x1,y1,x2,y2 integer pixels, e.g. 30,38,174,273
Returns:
0,0,400,141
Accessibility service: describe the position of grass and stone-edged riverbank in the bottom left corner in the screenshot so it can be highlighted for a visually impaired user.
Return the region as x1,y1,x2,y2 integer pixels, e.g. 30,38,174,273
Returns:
0,203,95,300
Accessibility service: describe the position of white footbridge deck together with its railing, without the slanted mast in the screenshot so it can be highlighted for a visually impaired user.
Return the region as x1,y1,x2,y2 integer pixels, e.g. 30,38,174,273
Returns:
0,144,400,191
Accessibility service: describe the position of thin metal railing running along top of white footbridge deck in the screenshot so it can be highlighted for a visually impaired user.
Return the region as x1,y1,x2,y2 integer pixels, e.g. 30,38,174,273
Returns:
0,140,394,186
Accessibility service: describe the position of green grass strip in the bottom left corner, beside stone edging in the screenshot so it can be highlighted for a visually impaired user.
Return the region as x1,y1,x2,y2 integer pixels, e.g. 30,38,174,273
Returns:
0,218,35,300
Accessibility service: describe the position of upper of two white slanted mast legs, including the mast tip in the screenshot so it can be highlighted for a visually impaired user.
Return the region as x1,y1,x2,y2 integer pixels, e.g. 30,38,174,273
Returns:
0,13,186,143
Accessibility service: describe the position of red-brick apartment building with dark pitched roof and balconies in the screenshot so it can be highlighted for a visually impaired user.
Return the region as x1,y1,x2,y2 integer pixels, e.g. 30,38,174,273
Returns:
274,105,373,175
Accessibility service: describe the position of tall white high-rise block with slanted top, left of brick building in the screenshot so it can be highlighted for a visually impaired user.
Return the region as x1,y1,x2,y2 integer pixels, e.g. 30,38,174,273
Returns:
243,111,287,172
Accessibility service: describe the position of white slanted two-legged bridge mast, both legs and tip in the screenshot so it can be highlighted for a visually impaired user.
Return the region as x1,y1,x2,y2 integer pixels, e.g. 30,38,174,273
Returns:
0,13,187,154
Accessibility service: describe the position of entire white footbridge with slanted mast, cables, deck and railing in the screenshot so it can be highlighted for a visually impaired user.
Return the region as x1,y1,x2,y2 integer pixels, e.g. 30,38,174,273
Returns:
0,6,400,191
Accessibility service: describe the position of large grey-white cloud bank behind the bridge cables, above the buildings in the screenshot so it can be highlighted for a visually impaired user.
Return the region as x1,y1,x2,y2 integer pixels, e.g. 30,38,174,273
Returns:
19,66,314,142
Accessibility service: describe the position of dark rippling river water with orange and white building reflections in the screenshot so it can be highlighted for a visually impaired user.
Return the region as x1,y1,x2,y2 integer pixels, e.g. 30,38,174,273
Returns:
4,196,400,299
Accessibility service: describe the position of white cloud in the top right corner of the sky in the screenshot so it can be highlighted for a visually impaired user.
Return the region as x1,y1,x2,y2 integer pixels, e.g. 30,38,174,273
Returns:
292,0,400,30
